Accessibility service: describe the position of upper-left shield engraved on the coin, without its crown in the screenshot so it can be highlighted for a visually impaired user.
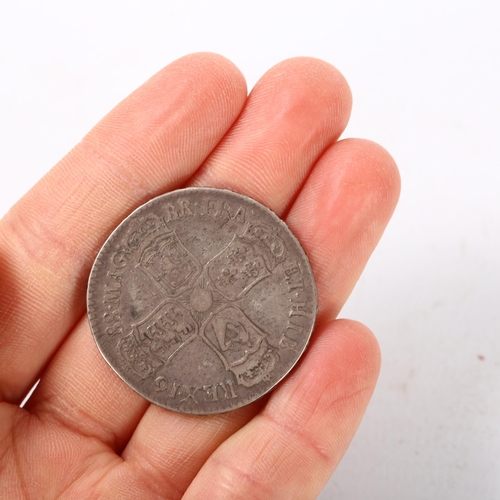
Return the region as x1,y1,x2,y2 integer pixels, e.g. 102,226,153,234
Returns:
138,230,202,296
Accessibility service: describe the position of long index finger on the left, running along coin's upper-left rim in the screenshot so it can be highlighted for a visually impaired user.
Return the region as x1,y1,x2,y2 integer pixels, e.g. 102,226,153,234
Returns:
0,54,246,402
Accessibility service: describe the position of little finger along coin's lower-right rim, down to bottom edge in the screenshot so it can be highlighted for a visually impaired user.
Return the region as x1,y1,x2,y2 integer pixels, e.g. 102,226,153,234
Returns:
183,320,380,500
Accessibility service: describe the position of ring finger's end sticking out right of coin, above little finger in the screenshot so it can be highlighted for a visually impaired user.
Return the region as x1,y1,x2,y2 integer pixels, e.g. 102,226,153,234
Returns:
286,139,400,320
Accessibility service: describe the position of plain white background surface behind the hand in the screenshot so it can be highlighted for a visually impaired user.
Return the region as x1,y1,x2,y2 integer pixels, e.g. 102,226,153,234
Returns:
0,0,500,500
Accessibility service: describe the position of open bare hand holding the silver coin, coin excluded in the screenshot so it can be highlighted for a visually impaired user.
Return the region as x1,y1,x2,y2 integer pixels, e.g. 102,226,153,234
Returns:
0,54,399,500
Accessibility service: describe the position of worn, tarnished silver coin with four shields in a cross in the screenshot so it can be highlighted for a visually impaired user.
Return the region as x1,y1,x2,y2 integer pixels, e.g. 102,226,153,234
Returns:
87,188,317,415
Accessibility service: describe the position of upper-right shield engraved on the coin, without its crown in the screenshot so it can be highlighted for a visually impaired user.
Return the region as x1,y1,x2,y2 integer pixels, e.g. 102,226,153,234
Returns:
207,236,271,301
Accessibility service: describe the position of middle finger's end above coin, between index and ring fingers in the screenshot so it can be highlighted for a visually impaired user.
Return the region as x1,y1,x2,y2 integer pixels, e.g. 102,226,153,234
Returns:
190,58,351,213
